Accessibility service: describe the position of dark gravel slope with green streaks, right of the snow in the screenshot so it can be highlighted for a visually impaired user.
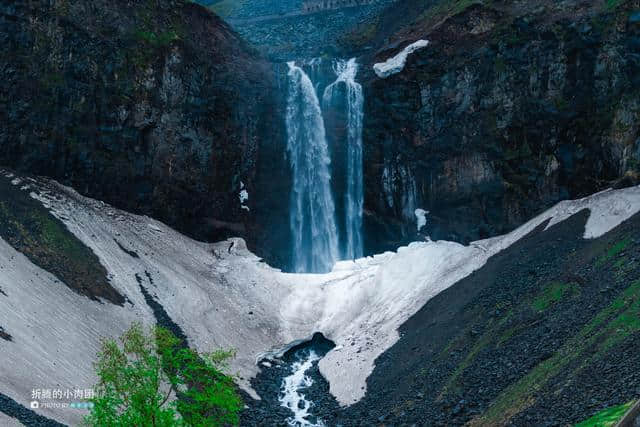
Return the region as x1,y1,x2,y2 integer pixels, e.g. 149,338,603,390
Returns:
345,196,640,426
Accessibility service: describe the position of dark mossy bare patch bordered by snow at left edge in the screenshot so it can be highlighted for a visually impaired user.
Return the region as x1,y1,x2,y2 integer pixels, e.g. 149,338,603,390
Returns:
0,178,125,305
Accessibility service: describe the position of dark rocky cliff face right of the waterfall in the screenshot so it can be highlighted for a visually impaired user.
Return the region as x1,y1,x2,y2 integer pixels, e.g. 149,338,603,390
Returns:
360,1,640,251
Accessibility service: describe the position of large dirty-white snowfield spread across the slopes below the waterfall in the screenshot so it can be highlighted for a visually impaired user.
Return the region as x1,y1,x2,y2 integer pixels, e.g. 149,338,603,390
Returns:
0,171,640,425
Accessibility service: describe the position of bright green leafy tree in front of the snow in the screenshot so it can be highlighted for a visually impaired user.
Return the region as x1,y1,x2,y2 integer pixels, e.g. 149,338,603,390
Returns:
86,323,242,427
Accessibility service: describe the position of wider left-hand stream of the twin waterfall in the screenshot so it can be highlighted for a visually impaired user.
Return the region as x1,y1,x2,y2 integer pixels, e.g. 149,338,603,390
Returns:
286,62,338,273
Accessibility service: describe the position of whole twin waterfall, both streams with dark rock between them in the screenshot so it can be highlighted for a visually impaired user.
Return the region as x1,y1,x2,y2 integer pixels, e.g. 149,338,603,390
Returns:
286,58,364,273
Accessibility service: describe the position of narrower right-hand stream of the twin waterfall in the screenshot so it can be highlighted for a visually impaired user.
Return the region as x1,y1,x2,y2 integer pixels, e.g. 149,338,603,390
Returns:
323,58,364,259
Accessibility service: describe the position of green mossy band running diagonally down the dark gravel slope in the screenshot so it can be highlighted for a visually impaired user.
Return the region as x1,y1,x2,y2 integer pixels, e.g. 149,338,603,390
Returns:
471,280,640,426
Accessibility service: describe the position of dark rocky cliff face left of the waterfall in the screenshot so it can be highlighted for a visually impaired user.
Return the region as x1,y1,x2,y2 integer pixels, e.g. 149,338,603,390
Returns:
0,0,281,247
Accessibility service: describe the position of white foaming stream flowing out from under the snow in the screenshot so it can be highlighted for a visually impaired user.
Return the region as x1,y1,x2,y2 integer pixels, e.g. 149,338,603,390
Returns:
280,350,324,427
